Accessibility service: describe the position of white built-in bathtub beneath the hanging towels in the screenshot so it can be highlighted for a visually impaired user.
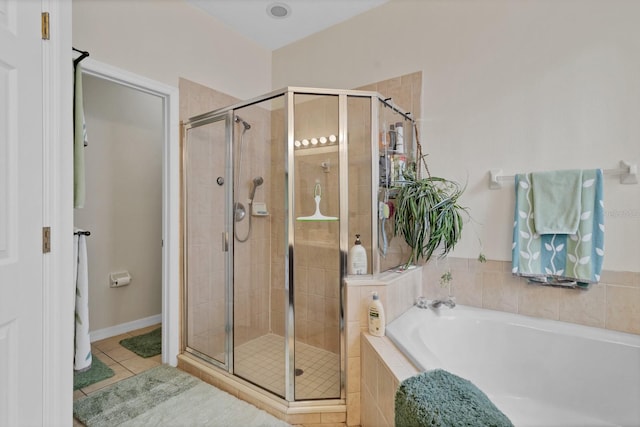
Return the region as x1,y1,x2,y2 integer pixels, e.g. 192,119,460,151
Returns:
387,305,640,427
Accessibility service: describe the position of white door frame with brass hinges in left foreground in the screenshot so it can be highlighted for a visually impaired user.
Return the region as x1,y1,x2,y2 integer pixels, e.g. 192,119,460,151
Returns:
43,0,75,425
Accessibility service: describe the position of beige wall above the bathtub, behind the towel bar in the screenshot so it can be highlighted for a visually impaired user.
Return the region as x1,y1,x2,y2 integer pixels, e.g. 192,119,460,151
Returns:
273,0,640,272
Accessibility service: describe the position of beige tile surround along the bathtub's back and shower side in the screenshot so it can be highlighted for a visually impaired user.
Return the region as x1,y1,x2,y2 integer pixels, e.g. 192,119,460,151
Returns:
346,257,640,427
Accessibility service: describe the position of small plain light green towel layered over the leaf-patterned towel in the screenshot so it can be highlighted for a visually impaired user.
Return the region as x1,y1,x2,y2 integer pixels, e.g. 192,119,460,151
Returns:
531,170,582,234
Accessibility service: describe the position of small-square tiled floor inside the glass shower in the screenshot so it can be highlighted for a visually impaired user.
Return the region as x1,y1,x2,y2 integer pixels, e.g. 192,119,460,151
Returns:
234,334,340,400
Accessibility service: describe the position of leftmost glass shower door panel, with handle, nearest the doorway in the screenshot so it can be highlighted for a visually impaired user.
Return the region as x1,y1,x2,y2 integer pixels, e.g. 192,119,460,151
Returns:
183,114,231,369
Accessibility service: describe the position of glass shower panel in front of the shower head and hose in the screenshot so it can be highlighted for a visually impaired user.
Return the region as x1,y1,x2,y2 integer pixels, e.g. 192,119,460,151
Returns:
233,96,285,397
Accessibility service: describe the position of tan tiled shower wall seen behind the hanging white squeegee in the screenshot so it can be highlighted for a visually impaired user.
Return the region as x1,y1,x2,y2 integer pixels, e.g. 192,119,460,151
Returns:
271,95,340,353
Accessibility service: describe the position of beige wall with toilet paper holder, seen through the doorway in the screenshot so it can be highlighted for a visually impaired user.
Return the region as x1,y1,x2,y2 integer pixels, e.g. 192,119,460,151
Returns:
74,75,164,331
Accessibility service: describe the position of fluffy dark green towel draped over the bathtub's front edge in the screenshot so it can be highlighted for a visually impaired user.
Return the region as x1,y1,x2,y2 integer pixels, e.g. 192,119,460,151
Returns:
395,369,513,427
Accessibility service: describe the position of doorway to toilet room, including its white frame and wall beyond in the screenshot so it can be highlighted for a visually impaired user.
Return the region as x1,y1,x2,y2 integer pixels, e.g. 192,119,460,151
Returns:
74,58,179,366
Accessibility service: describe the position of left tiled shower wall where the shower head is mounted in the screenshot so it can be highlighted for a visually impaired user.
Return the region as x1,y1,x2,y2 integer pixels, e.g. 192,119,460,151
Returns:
179,79,271,352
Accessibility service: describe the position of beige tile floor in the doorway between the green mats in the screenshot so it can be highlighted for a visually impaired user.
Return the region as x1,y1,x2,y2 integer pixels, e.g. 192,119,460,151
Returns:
73,324,162,427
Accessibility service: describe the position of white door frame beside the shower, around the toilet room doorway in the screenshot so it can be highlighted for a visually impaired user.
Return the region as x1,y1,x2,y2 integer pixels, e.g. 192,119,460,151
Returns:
82,57,180,366
